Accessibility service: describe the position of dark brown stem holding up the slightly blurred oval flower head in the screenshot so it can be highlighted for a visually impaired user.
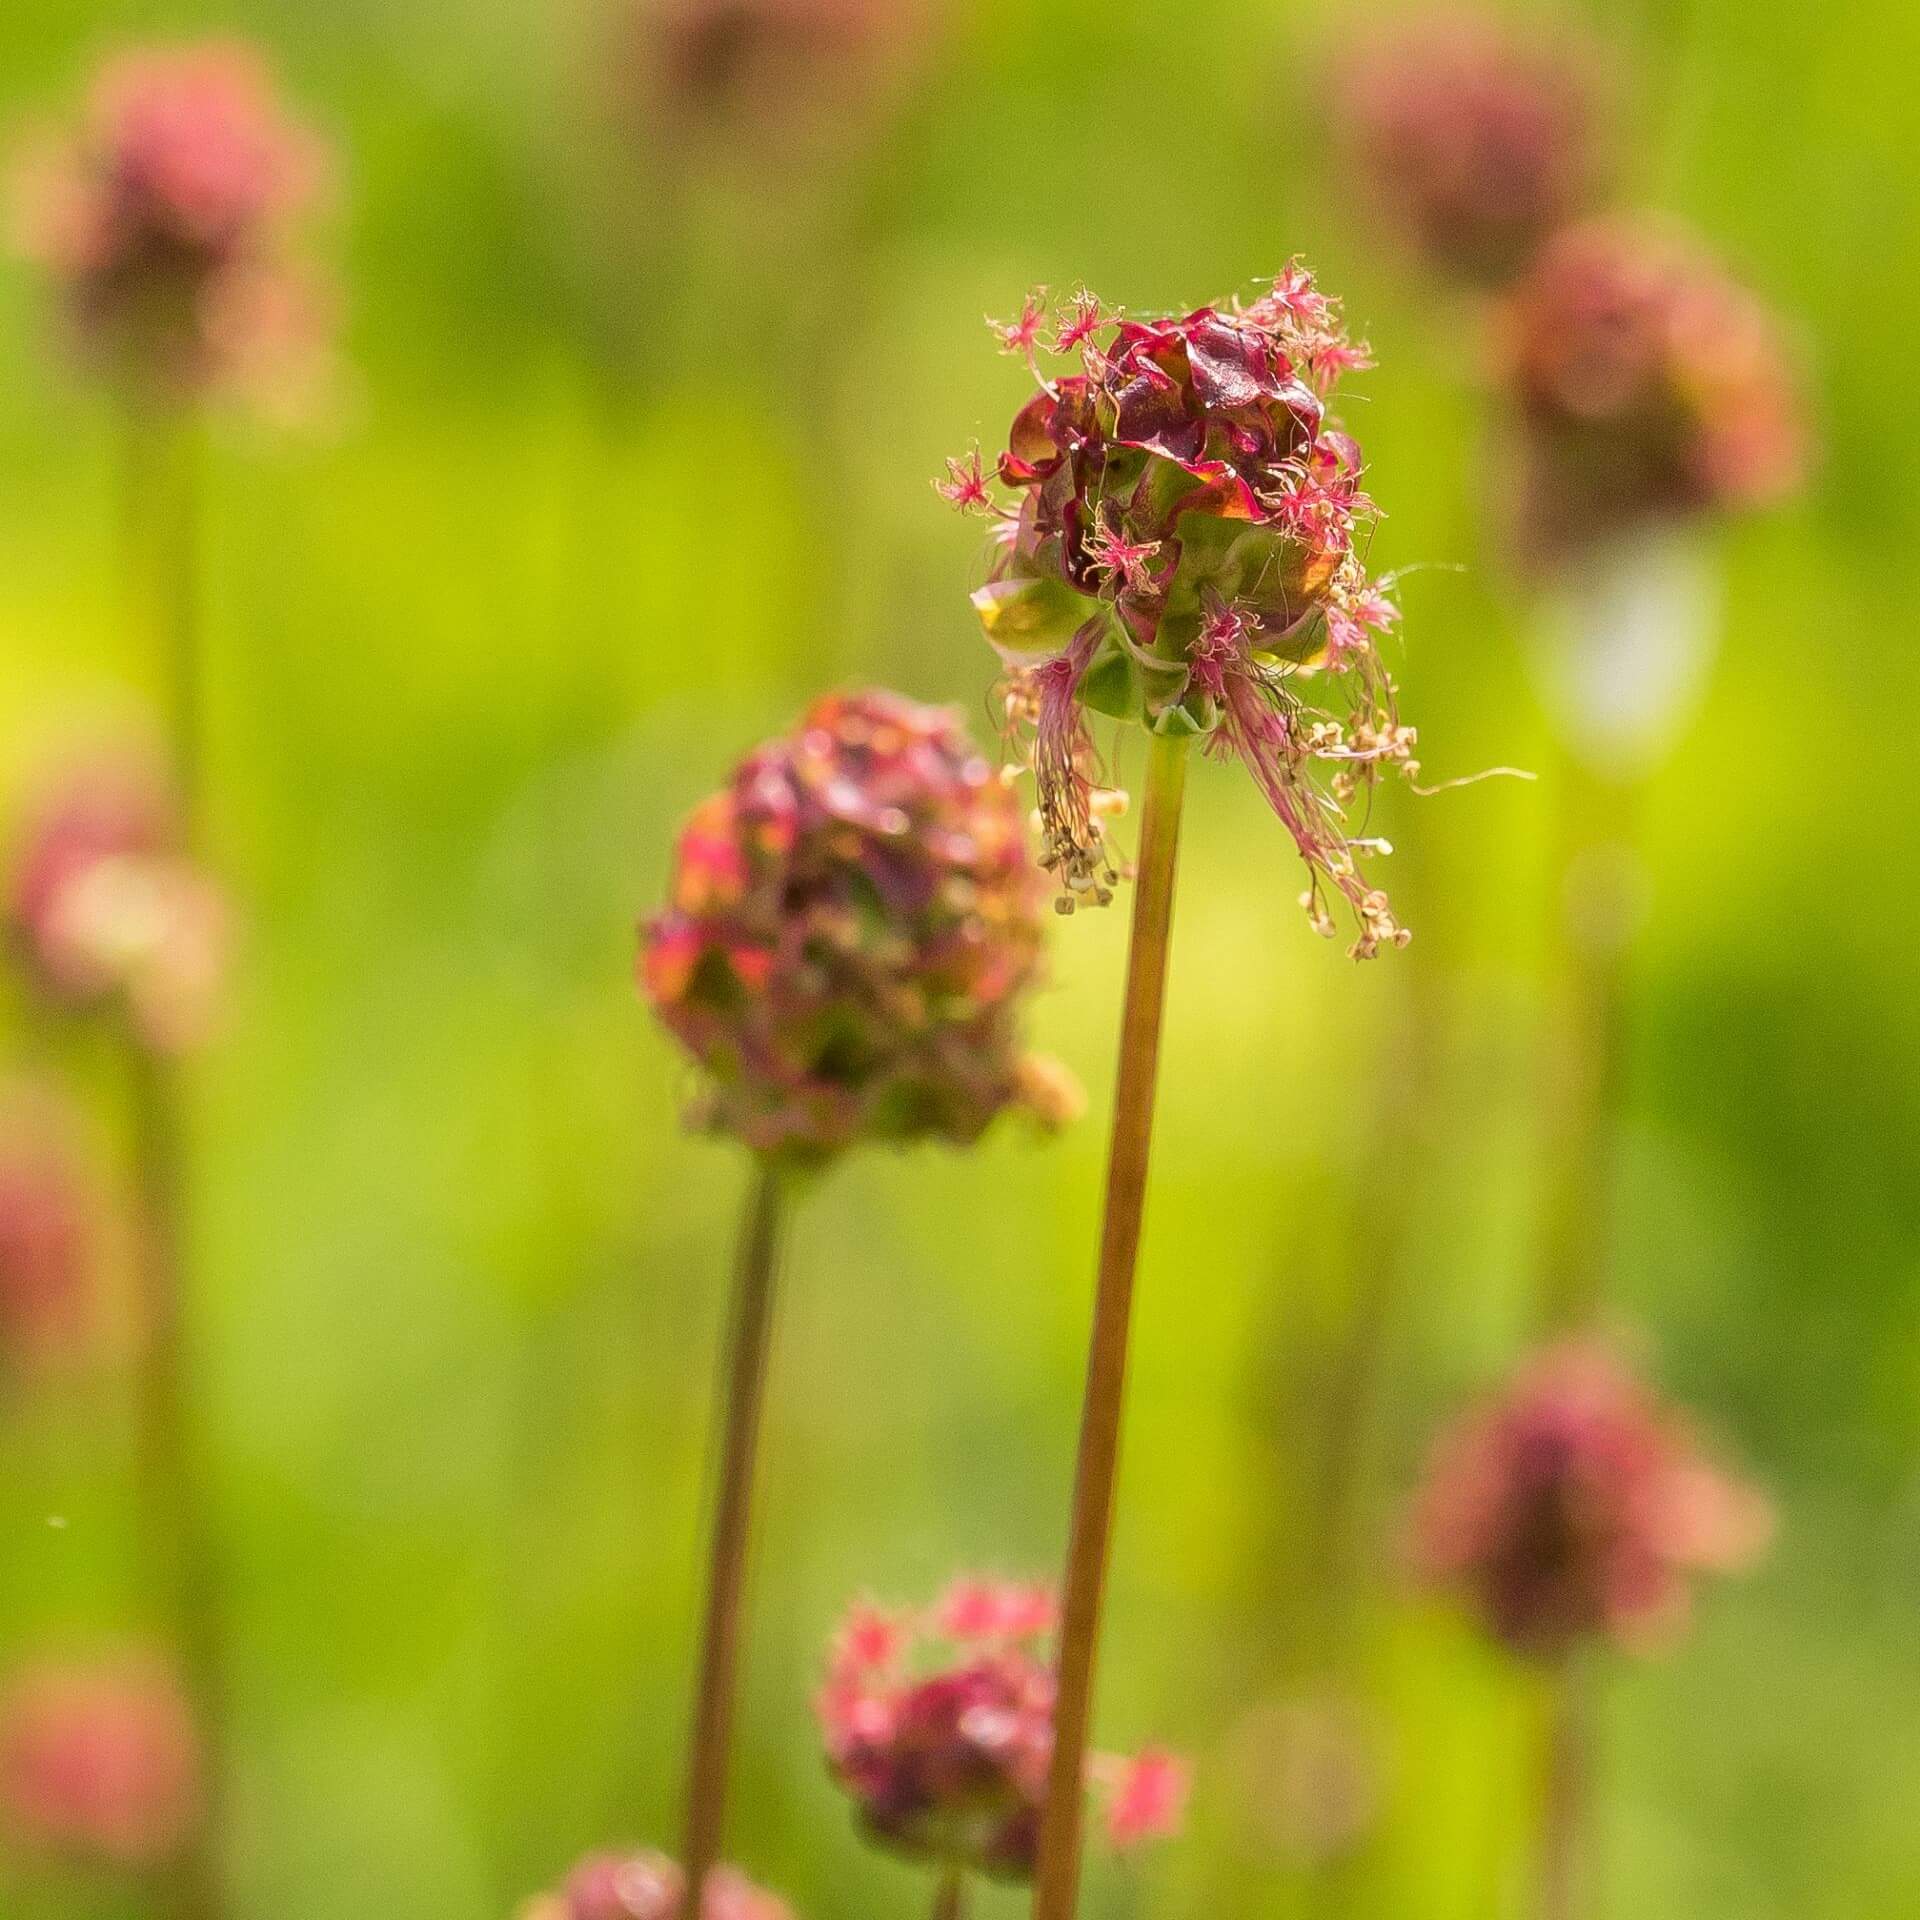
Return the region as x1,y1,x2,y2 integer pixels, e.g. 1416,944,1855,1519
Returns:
682,1160,787,1916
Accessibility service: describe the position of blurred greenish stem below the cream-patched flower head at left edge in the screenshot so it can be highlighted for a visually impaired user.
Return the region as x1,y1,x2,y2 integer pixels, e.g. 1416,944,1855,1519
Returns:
129,1044,227,1920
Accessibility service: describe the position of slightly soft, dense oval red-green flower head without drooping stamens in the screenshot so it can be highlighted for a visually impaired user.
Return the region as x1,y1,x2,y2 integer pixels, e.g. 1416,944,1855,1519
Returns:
641,693,1060,1162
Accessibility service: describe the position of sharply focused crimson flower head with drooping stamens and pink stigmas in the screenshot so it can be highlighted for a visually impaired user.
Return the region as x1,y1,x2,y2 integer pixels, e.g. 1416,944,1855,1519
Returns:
947,265,1415,956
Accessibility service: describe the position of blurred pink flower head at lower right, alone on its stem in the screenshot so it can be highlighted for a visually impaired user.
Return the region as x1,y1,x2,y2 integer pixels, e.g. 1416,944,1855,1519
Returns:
1413,1344,1772,1659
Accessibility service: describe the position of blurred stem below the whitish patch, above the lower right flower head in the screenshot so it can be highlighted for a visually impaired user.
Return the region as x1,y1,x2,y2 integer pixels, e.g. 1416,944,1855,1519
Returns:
1540,756,1638,1332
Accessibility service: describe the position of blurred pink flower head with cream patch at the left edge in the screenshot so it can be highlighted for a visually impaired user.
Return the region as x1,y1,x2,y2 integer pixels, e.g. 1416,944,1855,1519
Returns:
6,756,230,1052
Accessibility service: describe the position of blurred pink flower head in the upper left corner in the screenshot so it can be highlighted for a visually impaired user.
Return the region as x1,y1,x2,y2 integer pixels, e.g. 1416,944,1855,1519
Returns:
21,42,323,405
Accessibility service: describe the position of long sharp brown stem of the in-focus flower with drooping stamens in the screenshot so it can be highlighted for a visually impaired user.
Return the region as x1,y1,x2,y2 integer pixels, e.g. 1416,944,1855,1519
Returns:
1033,735,1187,1920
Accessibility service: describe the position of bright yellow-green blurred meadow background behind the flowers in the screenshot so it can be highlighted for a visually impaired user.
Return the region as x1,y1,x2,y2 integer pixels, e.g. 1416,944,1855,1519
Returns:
0,0,1920,1920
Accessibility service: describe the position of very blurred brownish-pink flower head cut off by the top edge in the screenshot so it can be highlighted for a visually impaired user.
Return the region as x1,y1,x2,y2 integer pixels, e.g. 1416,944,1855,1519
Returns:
624,0,929,152
